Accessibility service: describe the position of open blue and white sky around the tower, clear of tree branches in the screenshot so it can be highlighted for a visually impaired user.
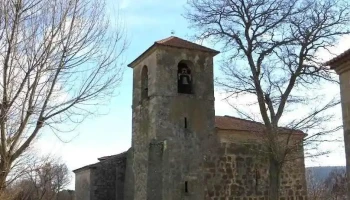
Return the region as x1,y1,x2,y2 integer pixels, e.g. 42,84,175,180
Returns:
37,0,350,189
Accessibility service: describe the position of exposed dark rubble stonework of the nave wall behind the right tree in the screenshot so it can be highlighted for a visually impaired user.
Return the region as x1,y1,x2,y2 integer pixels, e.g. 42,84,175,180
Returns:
205,130,306,200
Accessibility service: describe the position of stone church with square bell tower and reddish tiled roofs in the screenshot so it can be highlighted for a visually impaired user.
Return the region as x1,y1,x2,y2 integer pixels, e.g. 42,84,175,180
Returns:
74,37,306,200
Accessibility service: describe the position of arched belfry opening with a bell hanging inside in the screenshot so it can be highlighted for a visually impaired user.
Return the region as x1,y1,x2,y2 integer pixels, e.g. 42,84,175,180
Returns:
177,61,193,94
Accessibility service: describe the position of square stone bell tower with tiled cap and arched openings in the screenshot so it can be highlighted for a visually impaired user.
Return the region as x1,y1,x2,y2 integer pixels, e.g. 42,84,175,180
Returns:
128,37,219,200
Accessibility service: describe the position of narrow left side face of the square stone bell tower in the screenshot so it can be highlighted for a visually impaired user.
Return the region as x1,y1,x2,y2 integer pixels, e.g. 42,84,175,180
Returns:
131,52,156,200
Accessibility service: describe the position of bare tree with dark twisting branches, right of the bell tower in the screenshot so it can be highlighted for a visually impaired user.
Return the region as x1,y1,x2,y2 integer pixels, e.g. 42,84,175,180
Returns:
185,0,350,200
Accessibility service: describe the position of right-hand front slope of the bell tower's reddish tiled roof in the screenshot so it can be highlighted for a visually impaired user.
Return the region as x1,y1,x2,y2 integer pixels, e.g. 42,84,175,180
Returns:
155,36,219,54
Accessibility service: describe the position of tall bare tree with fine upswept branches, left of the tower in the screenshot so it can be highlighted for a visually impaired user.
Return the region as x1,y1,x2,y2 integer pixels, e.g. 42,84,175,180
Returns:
0,0,127,193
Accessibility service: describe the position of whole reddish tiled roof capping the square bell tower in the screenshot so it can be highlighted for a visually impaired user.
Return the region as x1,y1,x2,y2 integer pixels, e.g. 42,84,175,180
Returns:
128,36,220,67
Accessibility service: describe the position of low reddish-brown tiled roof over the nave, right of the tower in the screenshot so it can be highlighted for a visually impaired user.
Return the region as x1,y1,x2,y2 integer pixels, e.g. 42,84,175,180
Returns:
215,116,304,135
